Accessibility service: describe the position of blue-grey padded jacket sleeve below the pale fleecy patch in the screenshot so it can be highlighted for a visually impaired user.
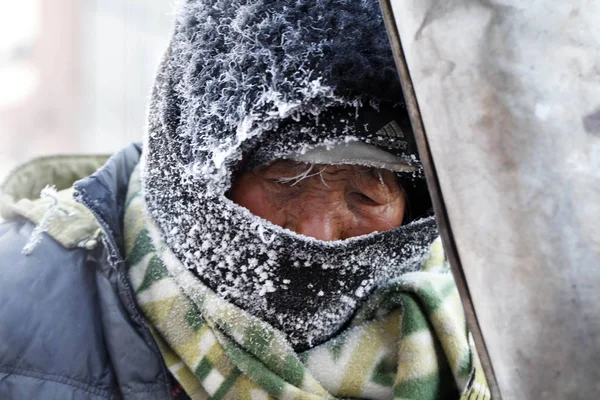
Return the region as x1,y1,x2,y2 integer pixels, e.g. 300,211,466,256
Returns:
0,218,114,398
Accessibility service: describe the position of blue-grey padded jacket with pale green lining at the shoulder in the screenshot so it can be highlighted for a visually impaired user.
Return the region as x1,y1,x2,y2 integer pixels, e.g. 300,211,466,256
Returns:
0,145,172,400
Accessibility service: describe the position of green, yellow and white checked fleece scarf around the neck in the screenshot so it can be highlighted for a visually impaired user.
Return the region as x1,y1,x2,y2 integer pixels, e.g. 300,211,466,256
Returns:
125,168,490,400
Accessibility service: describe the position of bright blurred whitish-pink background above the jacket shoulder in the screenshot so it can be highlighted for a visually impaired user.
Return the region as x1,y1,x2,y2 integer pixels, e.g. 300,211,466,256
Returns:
0,0,175,180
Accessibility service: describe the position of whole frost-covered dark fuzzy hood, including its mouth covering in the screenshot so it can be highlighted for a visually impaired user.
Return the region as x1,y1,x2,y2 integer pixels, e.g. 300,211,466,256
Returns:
142,0,436,350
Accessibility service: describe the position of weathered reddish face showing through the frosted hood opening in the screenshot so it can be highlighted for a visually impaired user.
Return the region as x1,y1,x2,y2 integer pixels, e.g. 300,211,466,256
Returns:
229,160,405,240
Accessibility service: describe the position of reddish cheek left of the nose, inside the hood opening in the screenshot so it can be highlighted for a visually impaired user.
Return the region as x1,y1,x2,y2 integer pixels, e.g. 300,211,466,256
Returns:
229,176,282,225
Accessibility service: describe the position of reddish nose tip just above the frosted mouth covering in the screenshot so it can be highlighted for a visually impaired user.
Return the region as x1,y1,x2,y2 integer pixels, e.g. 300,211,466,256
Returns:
290,196,353,241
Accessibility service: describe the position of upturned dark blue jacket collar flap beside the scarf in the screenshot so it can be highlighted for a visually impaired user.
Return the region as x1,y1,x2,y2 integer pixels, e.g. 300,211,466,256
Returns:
73,143,142,263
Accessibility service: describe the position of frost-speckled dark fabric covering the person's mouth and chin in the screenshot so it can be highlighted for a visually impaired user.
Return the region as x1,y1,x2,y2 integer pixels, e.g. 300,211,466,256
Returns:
143,150,437,351
